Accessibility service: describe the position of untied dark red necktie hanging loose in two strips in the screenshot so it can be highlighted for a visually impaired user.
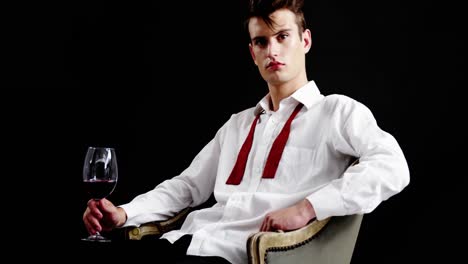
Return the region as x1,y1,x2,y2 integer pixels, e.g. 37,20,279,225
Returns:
226,103,303,185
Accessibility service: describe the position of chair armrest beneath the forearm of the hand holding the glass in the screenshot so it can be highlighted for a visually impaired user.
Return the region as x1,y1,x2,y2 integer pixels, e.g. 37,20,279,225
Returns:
125,207,192,240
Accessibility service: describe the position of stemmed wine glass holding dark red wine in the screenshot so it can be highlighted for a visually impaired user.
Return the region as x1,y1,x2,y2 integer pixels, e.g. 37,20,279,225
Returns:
82,147,118,242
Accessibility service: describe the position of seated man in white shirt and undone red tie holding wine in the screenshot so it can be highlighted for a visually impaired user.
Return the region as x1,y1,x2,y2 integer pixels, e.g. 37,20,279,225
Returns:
83,0,409,263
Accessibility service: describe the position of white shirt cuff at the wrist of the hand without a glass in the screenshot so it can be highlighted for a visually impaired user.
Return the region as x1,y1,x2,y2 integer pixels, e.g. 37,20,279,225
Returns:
307,184,347,220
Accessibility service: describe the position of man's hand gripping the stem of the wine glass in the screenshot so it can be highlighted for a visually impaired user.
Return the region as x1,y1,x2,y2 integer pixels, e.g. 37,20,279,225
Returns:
83,198,127,234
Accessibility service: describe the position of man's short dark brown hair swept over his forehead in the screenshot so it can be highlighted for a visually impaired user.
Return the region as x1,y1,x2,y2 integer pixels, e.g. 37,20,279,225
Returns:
245,0,307,37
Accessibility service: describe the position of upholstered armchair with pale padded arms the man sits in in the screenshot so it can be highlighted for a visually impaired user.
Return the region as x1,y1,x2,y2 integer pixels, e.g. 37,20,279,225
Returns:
125,208,363,264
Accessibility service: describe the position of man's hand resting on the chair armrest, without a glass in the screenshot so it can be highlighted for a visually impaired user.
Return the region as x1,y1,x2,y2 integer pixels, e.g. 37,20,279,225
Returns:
260,199,315,231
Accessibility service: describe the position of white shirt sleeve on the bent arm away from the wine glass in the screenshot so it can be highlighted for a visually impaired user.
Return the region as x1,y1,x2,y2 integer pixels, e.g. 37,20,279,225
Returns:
307,98,409,220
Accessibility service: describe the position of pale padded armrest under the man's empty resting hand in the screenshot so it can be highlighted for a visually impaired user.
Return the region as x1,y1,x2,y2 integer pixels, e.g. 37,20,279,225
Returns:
247,218,330,264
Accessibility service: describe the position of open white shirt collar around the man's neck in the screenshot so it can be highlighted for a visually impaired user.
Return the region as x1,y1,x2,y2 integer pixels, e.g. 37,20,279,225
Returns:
254,81,323,115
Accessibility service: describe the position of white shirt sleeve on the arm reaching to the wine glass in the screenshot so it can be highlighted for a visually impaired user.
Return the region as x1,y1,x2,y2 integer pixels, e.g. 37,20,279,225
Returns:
120,121,225,226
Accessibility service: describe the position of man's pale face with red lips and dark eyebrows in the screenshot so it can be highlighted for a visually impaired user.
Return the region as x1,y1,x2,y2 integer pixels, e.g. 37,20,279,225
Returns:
249,9,311,85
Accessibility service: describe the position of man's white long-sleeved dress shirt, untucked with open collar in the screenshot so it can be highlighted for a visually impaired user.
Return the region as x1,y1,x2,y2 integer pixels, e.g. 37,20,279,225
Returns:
121,81,409,264
